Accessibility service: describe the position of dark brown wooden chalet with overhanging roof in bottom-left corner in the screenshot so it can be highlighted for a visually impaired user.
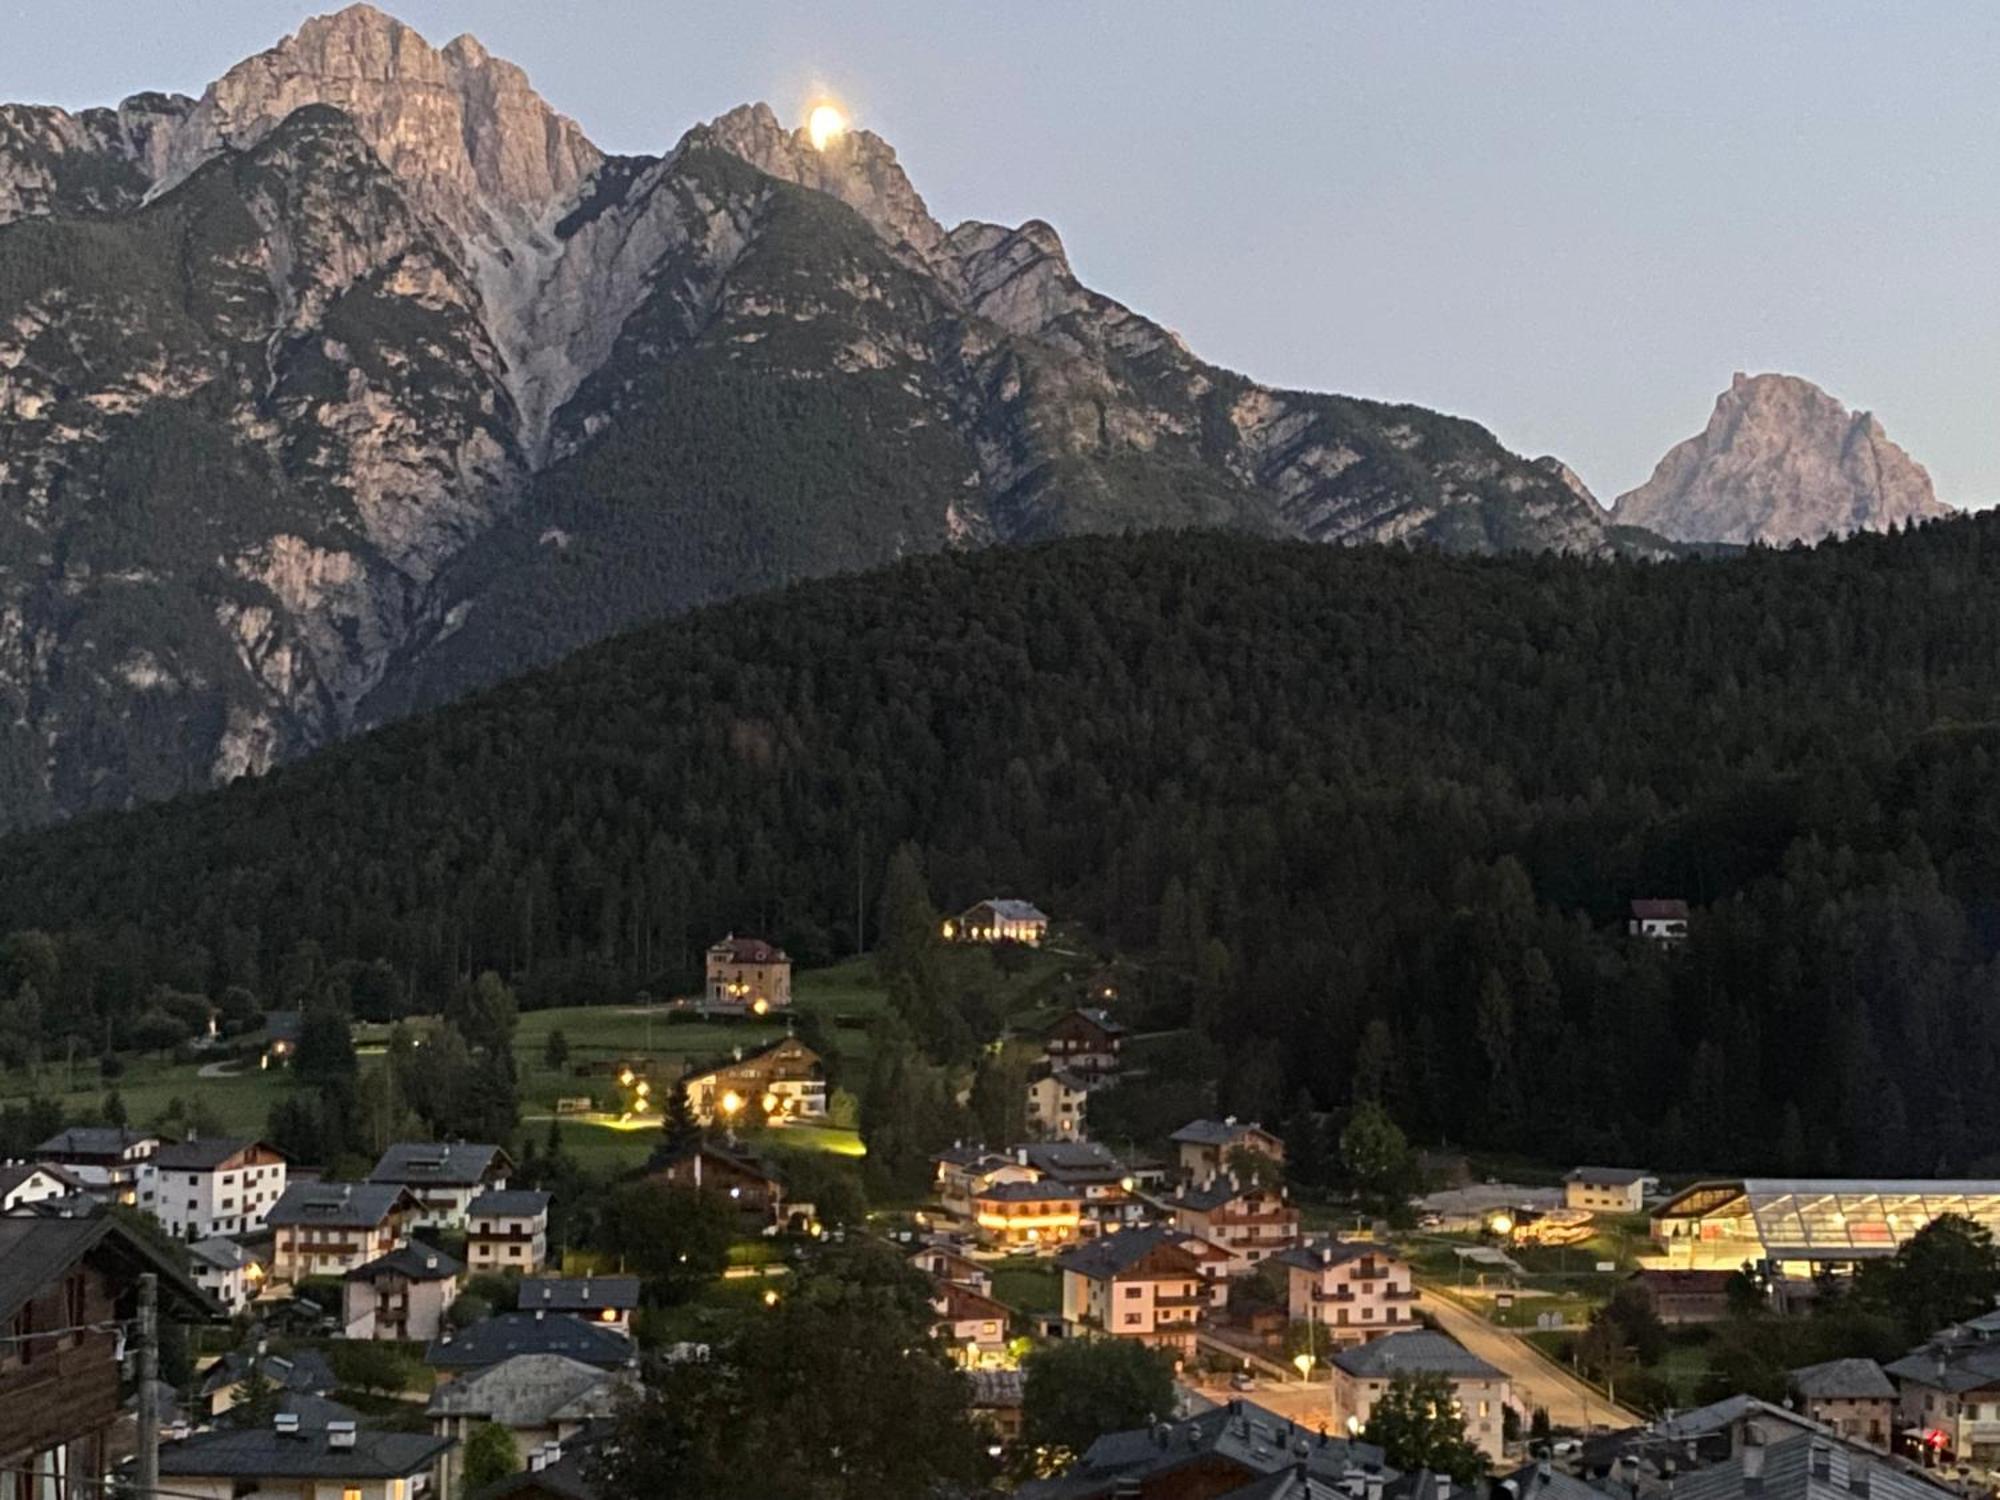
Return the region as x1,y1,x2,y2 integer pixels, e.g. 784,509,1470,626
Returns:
0,1214,222,1500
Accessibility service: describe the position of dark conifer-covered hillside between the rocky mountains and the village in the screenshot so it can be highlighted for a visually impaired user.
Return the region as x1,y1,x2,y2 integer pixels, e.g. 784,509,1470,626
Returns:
0,518,2000,1172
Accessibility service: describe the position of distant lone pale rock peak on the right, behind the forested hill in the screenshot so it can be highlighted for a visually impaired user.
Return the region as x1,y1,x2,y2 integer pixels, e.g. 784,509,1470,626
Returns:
1616,374,1954,546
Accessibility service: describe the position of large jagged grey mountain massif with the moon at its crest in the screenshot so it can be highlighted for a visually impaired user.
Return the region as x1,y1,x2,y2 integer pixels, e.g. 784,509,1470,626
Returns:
0,6,1612,824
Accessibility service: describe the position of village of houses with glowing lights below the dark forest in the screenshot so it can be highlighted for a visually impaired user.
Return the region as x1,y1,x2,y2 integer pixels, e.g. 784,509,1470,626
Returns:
0,892,2000,1500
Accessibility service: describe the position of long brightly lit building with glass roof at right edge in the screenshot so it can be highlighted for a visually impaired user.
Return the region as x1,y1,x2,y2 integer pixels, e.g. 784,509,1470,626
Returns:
1652,1178,2000,1276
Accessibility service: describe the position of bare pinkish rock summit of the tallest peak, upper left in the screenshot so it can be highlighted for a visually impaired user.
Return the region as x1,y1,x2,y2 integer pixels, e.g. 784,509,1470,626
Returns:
160,4,604,234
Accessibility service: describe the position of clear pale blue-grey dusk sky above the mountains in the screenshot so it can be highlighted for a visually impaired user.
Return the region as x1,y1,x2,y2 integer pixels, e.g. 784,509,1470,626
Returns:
0,0,2000,504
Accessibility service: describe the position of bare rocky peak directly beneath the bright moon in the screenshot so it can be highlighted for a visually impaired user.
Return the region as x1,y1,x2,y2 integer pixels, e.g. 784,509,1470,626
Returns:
704,104,948,272
